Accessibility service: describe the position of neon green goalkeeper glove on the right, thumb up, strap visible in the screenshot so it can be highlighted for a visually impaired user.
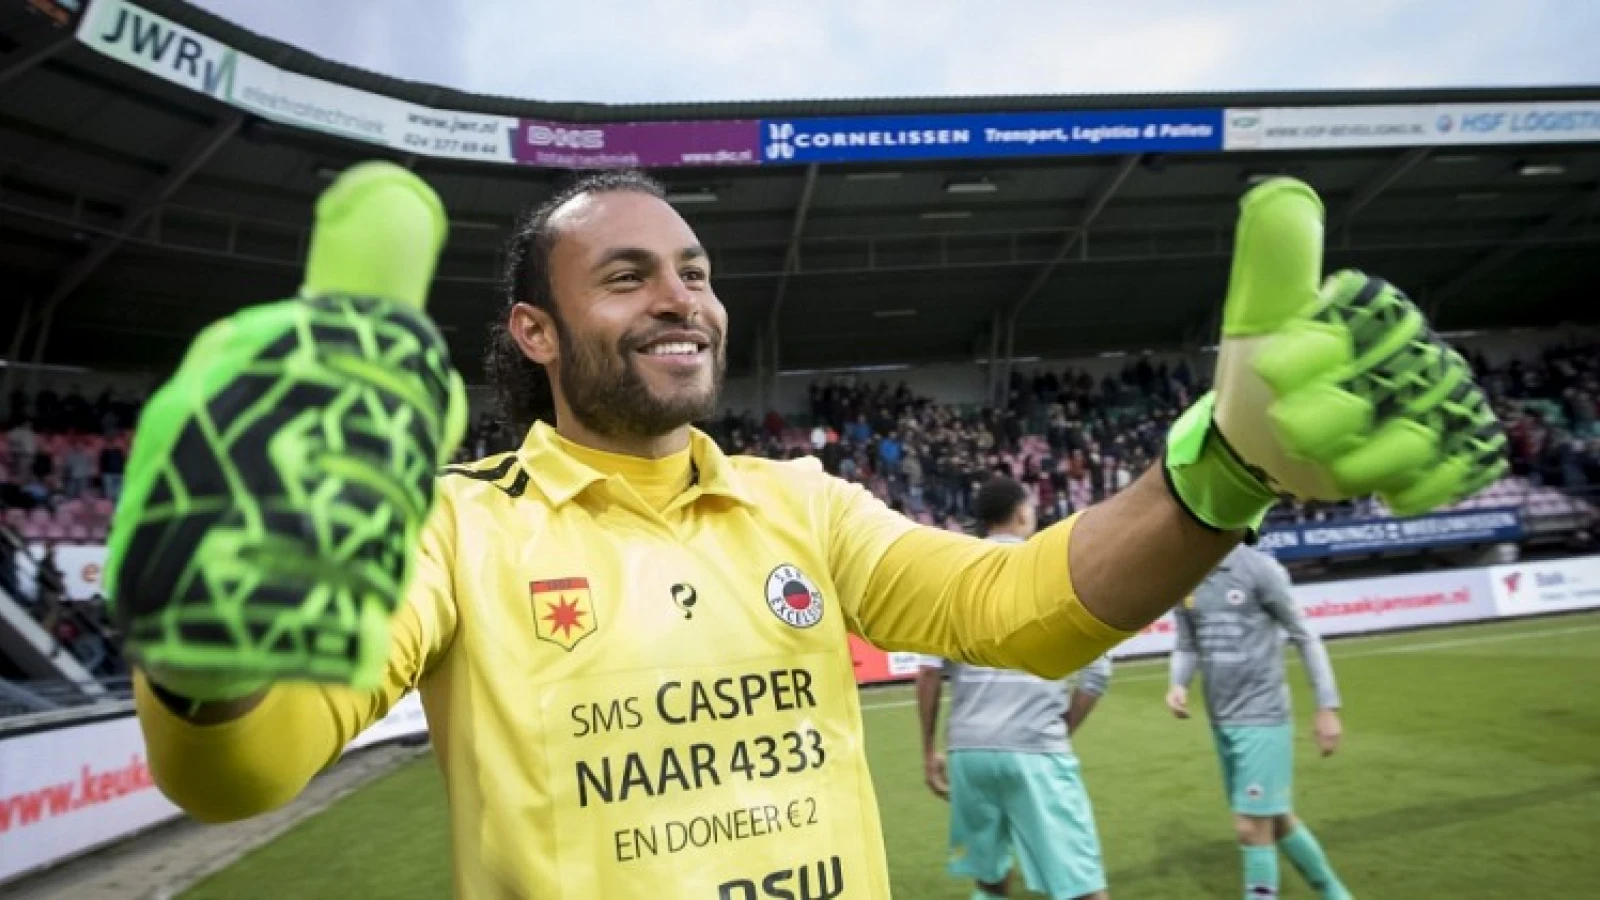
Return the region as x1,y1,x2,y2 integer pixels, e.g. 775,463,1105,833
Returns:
1166,178,1506,532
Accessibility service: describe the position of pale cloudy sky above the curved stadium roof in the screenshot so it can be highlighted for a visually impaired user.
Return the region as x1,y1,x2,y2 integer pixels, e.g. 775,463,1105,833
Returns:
194,0,1600,102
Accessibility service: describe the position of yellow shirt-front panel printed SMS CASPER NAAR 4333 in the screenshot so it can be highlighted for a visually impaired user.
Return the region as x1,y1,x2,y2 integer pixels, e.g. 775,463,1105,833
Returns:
539,653,875,900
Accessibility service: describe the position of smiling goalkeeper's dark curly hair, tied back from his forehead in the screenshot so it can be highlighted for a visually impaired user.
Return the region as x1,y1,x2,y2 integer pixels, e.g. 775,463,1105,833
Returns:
483,170,667,440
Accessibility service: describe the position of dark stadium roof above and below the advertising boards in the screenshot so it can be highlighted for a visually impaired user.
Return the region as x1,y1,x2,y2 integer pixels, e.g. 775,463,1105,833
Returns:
0,0,1600,385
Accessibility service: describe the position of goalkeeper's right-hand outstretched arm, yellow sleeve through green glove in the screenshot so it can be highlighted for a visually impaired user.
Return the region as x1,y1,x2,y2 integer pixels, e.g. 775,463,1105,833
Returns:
834,179,1506,677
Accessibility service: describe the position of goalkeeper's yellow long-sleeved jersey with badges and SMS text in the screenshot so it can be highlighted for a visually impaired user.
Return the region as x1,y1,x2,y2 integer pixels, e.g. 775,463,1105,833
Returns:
139,426,1126,900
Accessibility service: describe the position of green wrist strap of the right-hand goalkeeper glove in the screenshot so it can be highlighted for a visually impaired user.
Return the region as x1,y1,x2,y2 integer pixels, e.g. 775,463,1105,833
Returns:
1163,394,1278,540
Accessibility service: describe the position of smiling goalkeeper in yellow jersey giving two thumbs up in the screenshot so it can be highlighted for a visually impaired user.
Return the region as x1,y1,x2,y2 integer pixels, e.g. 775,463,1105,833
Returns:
107,163,1504,900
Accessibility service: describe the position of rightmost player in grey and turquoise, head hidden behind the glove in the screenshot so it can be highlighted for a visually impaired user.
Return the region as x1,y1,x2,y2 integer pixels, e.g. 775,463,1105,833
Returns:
1166,546,1350,900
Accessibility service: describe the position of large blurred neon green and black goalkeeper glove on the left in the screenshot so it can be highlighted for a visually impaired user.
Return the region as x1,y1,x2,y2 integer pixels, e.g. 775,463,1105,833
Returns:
106,163,467,700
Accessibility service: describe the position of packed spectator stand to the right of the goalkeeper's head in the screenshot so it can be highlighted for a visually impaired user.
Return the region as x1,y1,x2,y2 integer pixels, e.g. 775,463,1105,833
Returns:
694,344,1600,527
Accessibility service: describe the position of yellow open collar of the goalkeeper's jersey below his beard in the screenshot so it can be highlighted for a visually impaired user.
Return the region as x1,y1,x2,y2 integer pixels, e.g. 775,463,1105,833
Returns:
522,421,754,514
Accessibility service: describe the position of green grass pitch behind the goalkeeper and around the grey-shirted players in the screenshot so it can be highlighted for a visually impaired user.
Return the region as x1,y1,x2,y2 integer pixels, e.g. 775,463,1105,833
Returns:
175,615,1600,900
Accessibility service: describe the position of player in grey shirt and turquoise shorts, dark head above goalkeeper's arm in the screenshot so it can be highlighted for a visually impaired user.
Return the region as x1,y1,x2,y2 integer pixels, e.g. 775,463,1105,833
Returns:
917,477,1110,900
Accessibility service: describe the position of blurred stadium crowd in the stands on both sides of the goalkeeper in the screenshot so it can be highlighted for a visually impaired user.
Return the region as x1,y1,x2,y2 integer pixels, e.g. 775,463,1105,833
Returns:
0,336,1600,544
